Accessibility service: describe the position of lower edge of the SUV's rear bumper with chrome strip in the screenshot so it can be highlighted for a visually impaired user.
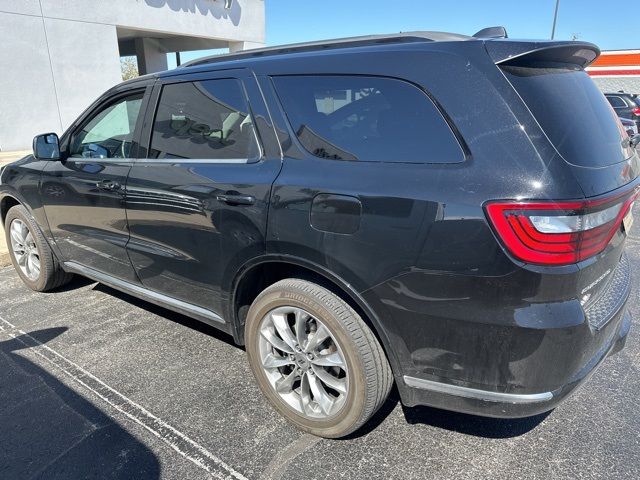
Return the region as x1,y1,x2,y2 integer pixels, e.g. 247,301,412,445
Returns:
398,308,631,418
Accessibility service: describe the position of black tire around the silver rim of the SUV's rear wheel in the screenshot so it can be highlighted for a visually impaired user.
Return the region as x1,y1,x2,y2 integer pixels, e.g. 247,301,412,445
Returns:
245,279,393,438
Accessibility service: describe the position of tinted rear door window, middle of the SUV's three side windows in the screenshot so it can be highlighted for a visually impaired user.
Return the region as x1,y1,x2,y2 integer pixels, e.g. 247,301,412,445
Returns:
149,79,257,159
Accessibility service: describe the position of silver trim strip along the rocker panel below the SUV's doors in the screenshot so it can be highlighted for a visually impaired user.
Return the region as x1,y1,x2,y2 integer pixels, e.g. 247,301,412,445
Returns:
64,262,226,324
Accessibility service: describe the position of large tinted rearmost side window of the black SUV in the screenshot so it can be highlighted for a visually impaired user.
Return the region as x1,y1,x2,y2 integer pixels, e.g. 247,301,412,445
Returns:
273,76,465,163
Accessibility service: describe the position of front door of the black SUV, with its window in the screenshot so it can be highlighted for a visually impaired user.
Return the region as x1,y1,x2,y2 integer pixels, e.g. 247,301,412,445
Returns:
40,90,149,282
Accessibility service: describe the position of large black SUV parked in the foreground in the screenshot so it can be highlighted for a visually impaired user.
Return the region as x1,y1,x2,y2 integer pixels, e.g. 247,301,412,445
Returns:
0,28,640,437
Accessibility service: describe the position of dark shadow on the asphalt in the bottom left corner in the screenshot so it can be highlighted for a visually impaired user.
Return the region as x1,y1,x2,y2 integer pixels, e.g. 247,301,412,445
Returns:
0,327,160,480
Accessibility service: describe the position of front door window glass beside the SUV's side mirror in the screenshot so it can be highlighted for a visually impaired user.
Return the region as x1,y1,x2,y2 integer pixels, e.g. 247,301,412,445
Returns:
70,93,142,158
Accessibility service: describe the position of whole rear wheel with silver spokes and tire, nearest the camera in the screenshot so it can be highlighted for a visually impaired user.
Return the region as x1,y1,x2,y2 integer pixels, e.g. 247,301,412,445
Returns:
245,279,393,438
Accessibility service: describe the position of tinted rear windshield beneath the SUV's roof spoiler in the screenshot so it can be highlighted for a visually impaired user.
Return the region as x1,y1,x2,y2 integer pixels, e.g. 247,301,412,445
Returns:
502,66,633,167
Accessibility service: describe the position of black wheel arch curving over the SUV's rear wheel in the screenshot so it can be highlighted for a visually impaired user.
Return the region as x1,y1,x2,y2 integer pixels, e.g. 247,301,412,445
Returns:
225,255,400,373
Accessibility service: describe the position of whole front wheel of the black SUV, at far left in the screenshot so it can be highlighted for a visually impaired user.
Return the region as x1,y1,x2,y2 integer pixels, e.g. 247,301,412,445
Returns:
4,205,73,292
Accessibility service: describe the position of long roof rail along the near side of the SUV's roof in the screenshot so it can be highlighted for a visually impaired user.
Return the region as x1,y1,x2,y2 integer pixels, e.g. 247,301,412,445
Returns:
180,31,472,68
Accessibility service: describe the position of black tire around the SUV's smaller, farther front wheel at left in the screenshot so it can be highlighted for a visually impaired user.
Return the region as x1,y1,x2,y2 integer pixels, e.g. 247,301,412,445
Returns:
4,205,73,292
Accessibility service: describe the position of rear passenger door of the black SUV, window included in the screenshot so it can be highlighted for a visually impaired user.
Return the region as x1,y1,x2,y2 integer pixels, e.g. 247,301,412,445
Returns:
127,70,281,318
